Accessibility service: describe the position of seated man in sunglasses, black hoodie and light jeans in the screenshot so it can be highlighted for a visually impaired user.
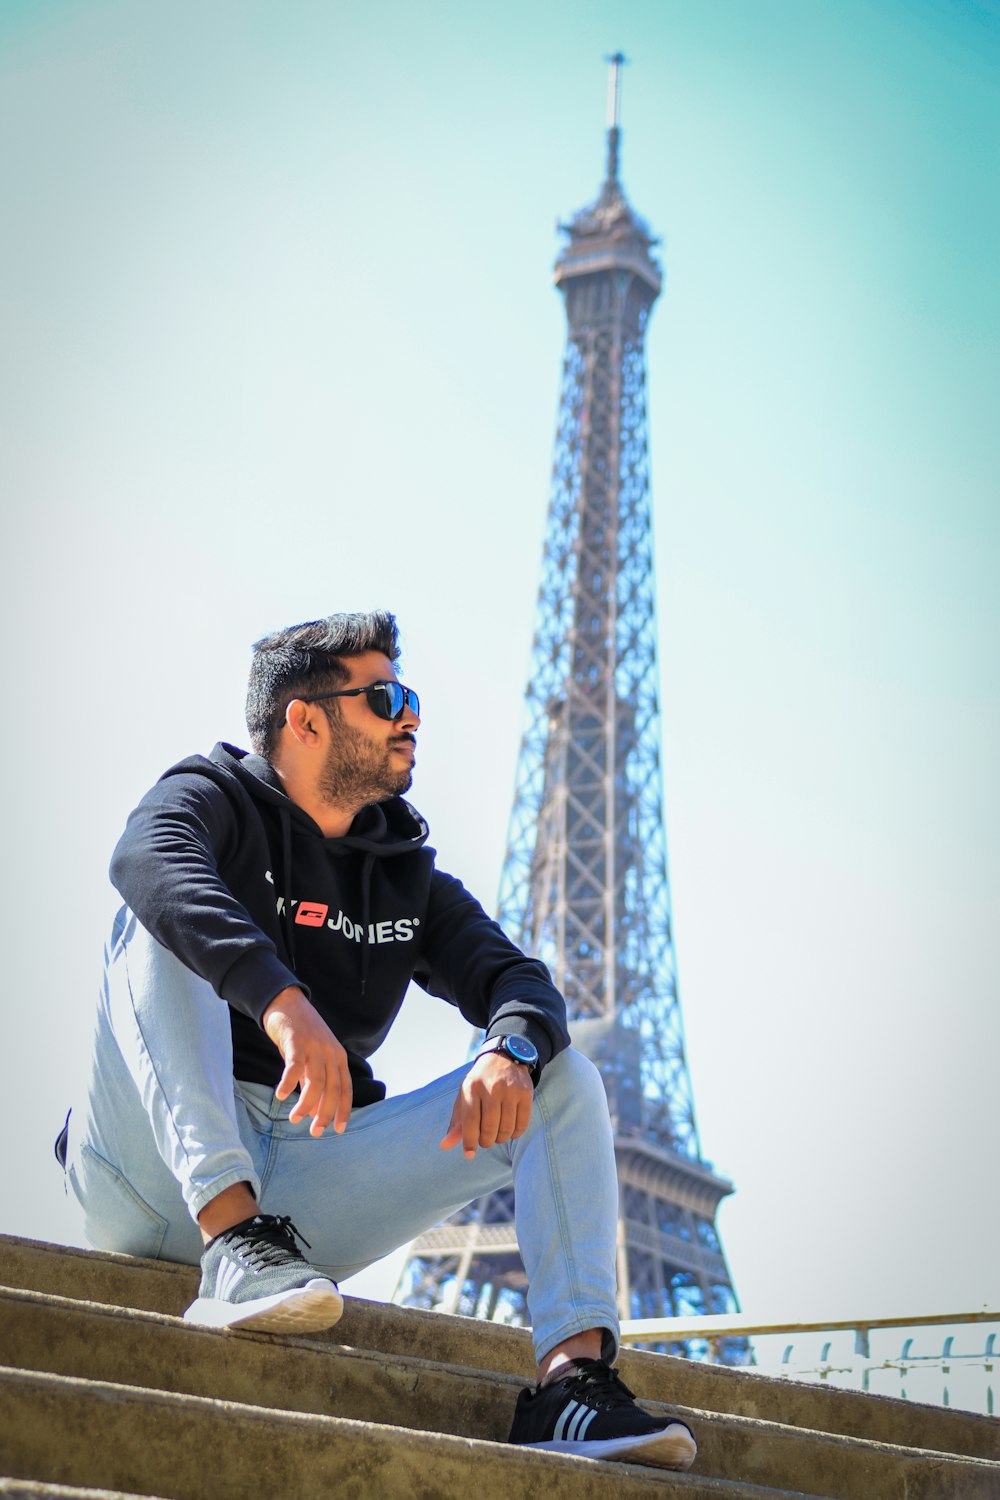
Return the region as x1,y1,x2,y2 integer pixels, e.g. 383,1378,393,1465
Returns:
60,612,696,1469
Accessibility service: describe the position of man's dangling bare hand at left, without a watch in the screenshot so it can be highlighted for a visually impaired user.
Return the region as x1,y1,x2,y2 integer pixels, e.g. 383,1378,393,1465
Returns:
264,986,354,1136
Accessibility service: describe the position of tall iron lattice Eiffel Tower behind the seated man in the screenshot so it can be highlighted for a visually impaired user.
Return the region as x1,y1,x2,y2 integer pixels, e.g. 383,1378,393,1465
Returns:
396,54,745,1359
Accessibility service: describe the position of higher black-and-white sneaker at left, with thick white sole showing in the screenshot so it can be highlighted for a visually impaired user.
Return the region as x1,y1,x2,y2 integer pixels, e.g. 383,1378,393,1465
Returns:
184,1214,343,1334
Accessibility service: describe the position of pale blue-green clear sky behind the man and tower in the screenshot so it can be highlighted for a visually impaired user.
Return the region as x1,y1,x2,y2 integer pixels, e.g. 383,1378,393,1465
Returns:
0,0,1000,1350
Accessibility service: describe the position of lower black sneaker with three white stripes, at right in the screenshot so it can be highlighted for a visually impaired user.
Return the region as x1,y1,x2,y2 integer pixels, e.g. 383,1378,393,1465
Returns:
507,1359,697,1469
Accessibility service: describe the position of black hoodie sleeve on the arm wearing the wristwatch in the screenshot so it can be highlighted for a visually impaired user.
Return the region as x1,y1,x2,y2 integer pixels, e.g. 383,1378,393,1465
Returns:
414,870,570,1068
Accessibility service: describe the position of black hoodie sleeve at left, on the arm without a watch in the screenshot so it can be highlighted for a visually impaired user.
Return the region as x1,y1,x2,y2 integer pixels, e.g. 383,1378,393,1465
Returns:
111,774,300,1025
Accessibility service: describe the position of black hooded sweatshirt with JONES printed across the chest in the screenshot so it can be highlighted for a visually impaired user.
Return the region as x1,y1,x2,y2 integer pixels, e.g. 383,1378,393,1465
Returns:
111,744,570,1106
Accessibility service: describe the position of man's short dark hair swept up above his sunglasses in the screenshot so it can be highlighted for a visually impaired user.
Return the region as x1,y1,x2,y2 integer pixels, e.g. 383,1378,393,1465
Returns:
246,609,399,761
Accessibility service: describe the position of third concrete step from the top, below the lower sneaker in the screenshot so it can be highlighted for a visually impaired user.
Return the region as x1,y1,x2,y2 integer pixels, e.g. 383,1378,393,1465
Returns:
0,1370,827,1500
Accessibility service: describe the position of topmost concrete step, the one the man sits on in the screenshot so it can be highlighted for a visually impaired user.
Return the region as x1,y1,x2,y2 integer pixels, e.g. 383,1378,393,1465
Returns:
0,1236,1000,1464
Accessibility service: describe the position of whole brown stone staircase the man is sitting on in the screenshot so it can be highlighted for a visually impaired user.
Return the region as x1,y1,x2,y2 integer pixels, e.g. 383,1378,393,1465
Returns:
0,1238,1000,1500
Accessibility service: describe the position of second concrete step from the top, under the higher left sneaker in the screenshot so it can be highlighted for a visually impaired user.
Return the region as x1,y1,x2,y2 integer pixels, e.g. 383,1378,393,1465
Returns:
0,1289,1000,1500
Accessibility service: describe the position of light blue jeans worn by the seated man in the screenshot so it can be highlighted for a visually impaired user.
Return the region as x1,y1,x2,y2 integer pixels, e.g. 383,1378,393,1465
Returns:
66,908,618,1359
